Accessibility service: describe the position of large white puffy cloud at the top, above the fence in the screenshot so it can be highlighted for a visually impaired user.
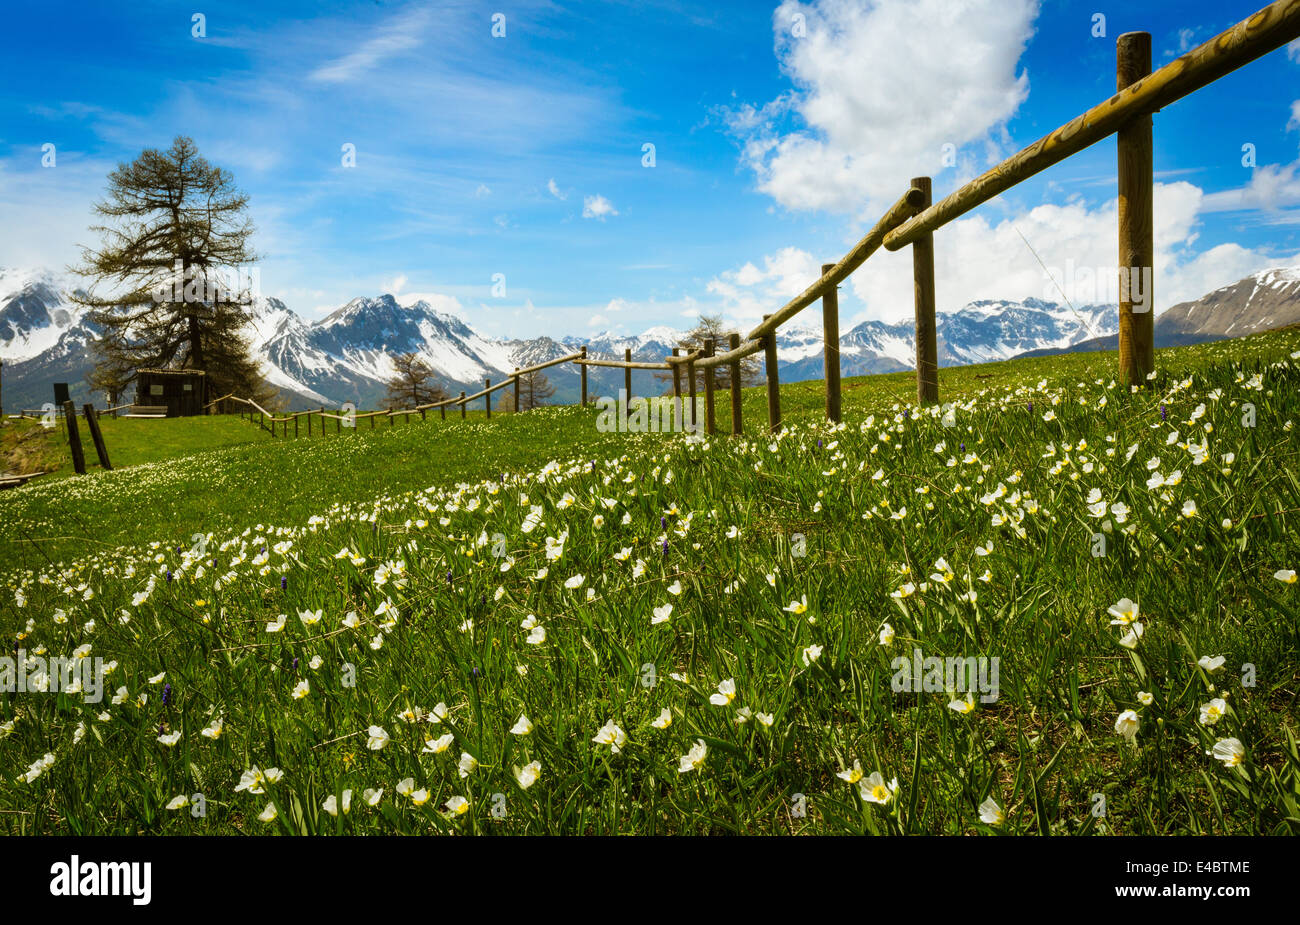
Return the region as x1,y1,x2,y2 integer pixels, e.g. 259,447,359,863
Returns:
729,0,1037,213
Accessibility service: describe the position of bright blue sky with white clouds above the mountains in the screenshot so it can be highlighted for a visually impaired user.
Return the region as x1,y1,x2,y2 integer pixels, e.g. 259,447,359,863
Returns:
0,0,1300,336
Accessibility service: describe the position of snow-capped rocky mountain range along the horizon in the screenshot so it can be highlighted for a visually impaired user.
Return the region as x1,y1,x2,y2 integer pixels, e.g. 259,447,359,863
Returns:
0,268,1300,412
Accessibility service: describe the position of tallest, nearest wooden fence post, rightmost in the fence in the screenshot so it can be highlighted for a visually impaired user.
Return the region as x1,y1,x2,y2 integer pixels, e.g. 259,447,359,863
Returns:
1115,32,1156,386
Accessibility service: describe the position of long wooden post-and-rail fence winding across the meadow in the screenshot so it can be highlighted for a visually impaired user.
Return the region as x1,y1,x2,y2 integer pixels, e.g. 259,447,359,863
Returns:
211,0,1300,434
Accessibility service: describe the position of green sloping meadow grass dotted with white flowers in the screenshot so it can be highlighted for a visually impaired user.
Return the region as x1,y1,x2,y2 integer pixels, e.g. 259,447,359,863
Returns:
0,331,1300,834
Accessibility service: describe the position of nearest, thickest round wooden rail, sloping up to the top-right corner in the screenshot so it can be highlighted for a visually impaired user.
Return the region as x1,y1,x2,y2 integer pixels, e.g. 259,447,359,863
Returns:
883,0,1300,249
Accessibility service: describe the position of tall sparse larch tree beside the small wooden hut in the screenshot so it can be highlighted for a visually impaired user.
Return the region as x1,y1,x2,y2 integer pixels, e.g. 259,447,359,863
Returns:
69,136,276,405
